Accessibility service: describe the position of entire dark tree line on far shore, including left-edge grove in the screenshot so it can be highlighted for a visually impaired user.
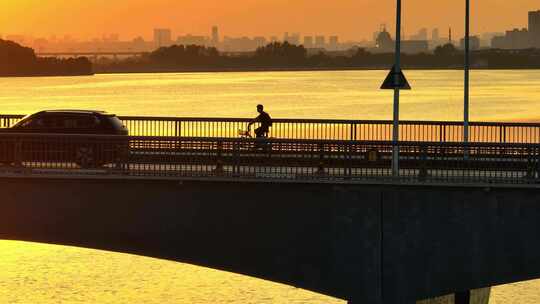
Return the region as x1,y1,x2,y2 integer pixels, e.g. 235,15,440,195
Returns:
0,39,540,76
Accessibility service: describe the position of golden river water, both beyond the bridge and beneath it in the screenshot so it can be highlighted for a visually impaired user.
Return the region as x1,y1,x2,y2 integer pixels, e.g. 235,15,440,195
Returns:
0,71,540,304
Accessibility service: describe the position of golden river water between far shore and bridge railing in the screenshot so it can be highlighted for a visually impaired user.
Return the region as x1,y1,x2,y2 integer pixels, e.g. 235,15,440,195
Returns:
0,71,540,121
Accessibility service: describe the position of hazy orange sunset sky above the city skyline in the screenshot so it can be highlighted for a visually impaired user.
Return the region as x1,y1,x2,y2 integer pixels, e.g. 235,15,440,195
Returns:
0,0,540,40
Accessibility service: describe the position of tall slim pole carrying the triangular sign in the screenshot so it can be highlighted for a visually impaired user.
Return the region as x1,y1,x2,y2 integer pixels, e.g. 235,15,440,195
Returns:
392,0,401,177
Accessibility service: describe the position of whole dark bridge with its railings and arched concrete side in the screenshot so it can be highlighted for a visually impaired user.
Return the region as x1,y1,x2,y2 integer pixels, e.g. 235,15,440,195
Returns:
0,115,540,304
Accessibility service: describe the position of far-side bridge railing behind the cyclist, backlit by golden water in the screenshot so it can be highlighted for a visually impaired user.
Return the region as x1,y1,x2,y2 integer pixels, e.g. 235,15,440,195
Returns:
0,115,540,143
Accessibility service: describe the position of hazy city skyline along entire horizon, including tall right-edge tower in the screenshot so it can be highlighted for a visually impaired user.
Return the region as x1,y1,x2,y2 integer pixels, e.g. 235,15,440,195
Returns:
4,4,540,54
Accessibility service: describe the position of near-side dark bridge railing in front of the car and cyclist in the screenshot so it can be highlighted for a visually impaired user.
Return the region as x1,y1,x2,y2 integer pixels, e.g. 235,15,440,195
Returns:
0,134,540,185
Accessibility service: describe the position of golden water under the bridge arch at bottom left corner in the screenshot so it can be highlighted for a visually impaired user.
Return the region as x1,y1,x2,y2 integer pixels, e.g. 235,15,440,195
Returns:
0,241,343,304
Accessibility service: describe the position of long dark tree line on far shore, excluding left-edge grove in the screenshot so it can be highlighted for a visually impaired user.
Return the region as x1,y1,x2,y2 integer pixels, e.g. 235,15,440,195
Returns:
96,42,540,72
